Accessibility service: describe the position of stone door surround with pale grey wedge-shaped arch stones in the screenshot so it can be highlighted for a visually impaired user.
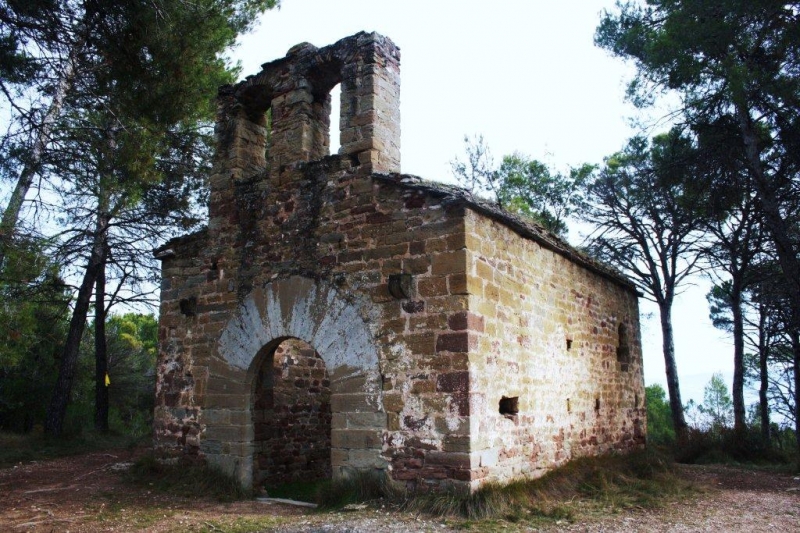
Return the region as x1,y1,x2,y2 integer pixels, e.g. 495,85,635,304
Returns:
212,276,387,487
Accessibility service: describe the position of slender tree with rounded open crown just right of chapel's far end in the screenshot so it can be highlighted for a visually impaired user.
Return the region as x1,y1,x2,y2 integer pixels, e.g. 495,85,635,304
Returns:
583,129,707,434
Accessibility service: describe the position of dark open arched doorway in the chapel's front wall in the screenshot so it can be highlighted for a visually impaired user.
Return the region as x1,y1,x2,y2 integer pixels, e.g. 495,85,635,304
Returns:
251,338,331,491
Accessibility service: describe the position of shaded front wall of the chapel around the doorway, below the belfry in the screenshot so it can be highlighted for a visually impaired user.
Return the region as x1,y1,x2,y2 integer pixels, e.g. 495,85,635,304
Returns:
157,157,482,487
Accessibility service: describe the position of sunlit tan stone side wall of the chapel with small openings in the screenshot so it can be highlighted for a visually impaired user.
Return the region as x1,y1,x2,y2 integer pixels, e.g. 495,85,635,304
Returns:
465,211,646,482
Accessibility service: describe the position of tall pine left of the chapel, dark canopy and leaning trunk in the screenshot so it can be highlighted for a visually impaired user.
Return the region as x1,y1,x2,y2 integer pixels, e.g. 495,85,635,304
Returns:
0,0,277,434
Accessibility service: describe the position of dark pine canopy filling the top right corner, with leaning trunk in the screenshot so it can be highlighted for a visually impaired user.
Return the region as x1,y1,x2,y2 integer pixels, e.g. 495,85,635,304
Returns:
596,0,800,445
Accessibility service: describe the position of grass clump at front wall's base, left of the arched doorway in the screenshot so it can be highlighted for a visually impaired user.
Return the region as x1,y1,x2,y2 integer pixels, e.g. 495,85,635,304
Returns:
126,455,251,502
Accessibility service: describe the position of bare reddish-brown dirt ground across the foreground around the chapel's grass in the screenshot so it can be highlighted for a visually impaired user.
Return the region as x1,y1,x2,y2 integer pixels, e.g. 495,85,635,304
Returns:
0,450,800,533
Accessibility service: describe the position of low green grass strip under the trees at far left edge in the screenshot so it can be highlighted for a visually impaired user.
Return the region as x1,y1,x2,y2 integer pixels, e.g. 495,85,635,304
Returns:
0,431,142,468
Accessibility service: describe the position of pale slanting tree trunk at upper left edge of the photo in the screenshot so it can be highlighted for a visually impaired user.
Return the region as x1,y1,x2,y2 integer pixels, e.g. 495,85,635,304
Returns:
0,41,83,265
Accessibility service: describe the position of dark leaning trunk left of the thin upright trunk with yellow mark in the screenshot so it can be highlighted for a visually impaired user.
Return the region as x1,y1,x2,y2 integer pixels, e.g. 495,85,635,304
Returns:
45,210,109,436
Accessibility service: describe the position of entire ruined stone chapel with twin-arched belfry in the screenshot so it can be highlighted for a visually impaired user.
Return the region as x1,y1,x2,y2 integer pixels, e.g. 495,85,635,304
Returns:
155,33,645,489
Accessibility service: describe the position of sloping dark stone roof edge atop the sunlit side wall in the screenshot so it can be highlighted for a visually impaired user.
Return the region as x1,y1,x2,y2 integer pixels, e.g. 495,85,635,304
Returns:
372,173,639,295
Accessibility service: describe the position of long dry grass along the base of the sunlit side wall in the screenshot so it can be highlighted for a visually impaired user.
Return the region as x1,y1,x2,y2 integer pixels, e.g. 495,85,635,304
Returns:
296,451,694,524
